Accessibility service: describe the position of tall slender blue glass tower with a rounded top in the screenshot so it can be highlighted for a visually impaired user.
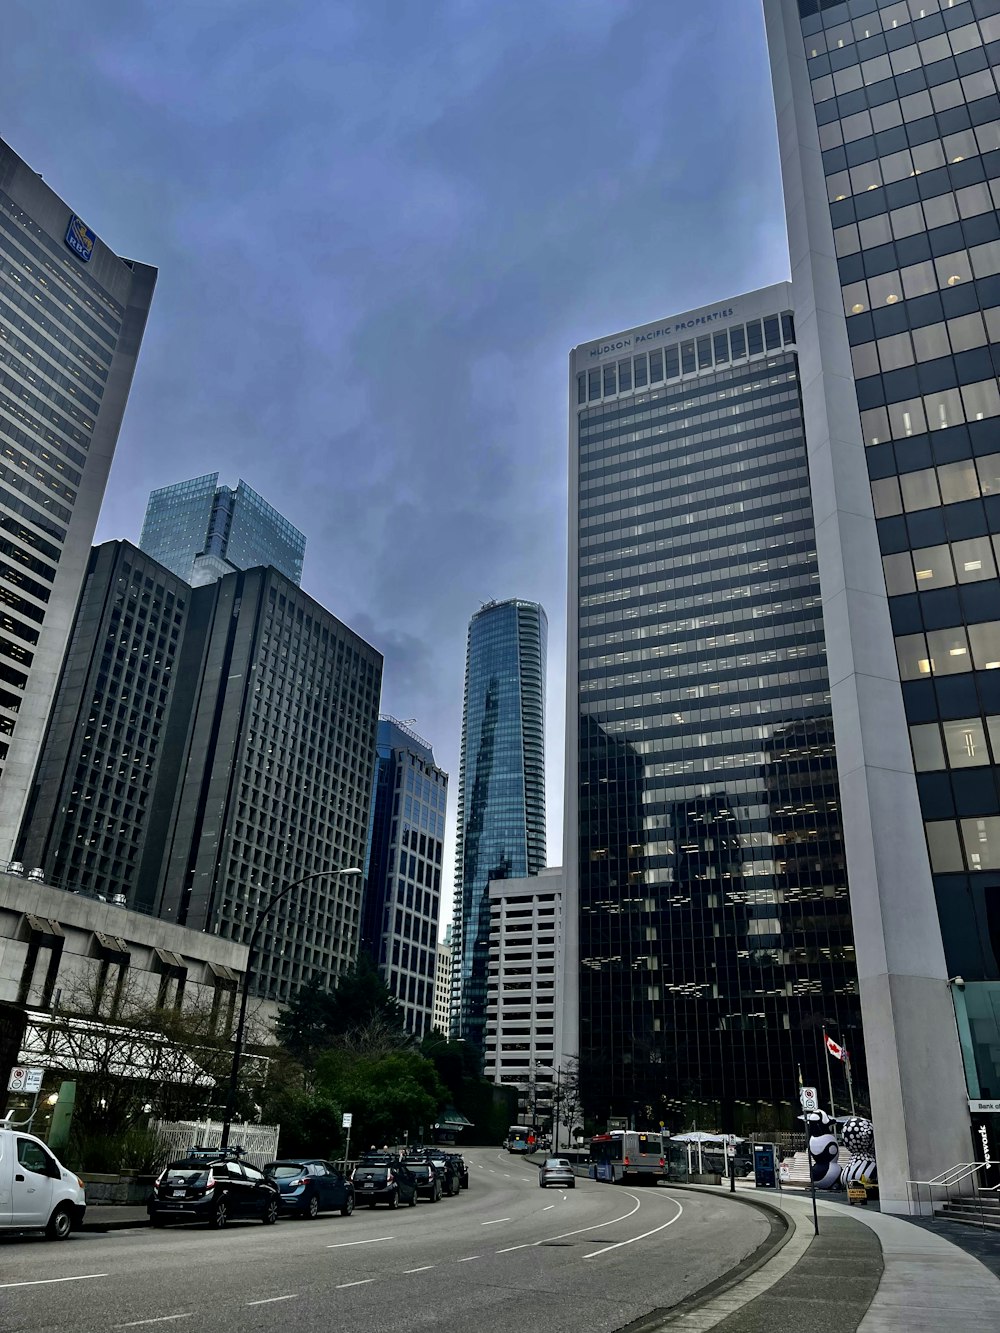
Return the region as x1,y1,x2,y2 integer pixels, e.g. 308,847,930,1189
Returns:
452,599,548,1052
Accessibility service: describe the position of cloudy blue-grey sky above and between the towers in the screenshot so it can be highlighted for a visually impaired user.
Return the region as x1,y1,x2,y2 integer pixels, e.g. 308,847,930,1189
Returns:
0,0,787,917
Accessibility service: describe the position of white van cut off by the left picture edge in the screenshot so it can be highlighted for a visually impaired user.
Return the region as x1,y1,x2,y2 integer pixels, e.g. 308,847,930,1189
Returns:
0,1120,87,1241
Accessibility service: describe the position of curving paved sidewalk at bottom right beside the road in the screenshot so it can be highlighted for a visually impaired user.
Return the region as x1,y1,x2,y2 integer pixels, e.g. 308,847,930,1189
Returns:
663,1189,1000,1333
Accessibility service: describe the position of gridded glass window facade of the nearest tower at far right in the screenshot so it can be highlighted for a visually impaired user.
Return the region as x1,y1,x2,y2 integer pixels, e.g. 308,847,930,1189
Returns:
799,0,1000,1096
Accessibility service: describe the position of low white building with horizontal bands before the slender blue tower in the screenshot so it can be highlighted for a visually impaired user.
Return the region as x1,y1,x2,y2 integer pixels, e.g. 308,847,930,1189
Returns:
484,866,564,1125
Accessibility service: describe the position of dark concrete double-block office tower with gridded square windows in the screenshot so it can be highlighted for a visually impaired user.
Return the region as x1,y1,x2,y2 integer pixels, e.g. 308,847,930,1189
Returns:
19,543,381,1001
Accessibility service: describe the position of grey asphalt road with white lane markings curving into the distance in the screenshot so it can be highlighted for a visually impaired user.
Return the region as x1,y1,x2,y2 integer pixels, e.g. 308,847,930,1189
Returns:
0,1149,768,1333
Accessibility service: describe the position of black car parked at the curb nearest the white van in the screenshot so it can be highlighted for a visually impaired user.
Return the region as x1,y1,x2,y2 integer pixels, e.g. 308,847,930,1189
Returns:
145,1148,281,1229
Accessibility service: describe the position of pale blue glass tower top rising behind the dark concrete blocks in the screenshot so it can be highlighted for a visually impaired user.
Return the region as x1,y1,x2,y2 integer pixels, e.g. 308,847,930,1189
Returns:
139,472,305,587
